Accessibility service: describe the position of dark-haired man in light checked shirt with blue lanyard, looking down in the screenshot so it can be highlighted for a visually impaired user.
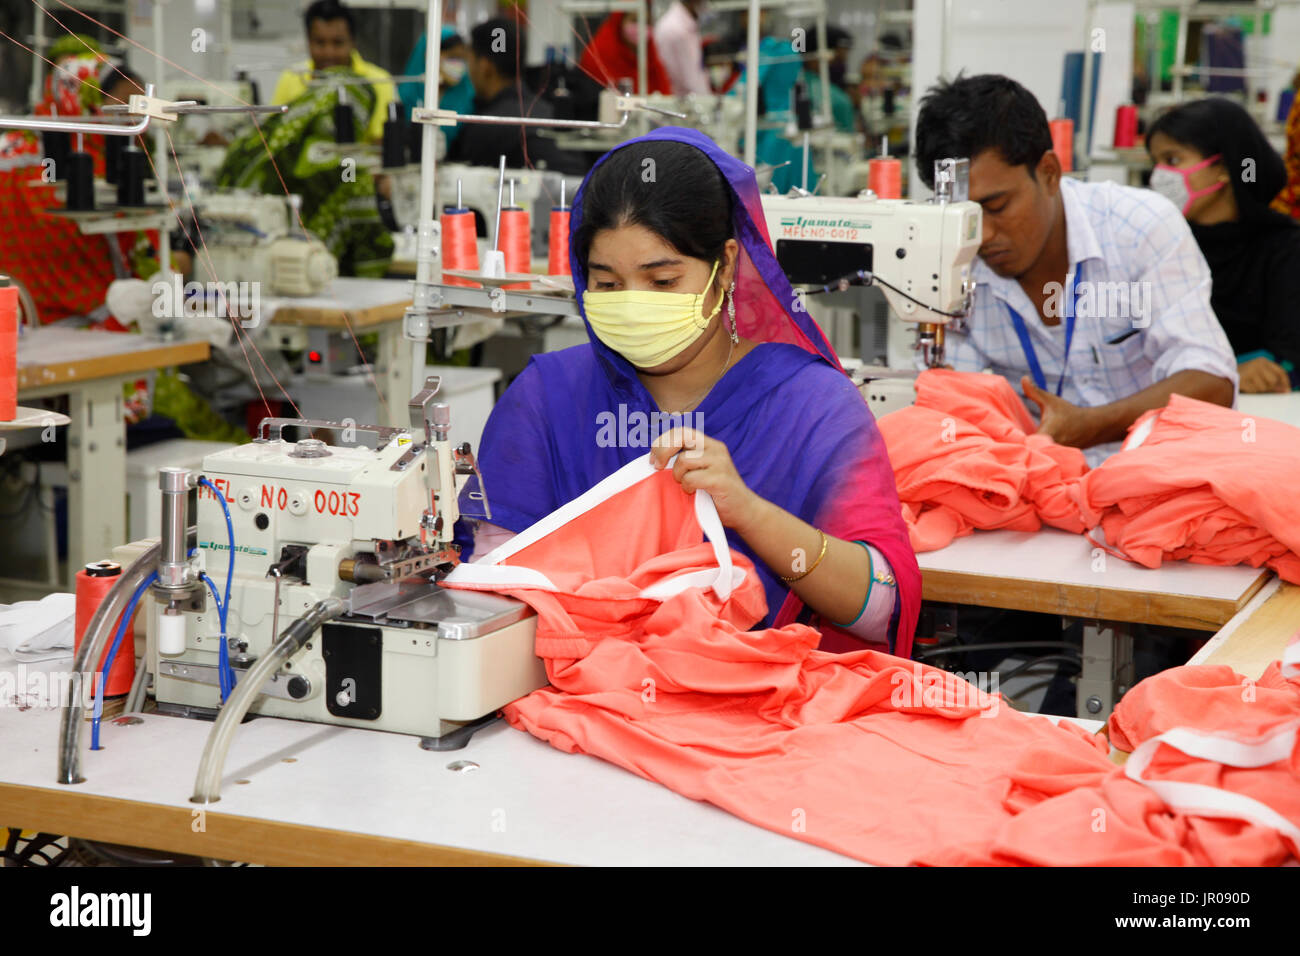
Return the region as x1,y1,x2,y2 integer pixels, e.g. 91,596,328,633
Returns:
915,74,1236,466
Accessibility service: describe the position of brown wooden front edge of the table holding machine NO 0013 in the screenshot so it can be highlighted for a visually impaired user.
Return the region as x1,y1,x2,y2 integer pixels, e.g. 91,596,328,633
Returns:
0,782,555,866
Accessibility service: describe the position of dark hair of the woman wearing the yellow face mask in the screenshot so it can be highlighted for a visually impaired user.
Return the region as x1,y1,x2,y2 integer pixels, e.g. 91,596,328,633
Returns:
573,140,733,273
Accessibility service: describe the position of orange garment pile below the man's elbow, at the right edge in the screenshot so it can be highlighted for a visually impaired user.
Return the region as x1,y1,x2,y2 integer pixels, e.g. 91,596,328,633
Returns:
1071,395,1300,583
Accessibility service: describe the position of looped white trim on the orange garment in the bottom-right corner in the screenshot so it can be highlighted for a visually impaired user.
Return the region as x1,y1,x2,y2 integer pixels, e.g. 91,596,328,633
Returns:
1125,721,1300,845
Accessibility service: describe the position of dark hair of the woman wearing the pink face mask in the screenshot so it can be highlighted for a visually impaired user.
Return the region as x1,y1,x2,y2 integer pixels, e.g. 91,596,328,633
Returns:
1147,96,1287,219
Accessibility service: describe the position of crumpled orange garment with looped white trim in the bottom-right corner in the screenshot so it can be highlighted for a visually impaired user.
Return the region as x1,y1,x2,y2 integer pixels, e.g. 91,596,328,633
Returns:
924,643,1300,866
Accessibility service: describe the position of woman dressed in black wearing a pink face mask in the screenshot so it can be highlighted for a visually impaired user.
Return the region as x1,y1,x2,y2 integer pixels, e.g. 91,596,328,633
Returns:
1147,98,1300,392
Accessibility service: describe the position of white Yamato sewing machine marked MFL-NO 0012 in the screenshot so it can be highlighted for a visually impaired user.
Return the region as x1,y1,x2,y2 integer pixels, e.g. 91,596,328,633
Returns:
763,160,982,418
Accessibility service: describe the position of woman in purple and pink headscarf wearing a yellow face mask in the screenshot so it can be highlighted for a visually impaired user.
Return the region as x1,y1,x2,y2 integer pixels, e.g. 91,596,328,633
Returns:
460,127,920,656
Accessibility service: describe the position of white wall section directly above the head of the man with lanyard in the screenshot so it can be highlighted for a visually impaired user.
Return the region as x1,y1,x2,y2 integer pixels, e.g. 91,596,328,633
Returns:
911,0,1134,195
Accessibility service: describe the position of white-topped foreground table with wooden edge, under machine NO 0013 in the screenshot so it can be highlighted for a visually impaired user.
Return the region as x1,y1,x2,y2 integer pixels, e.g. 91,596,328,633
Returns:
0,652,1100,866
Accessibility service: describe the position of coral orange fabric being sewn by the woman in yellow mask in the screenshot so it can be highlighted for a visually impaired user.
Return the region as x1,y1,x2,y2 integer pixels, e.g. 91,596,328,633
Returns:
445,463,1128,864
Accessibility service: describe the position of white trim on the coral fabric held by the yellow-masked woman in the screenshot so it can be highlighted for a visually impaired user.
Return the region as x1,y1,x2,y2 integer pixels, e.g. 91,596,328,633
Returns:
445,455,745,601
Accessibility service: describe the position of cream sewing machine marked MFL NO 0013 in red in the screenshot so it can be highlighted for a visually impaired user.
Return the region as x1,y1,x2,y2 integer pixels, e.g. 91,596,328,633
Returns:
142,377,547,749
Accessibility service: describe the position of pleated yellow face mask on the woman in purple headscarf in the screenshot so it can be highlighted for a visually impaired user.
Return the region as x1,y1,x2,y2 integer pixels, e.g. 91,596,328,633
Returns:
582,263,723,368
